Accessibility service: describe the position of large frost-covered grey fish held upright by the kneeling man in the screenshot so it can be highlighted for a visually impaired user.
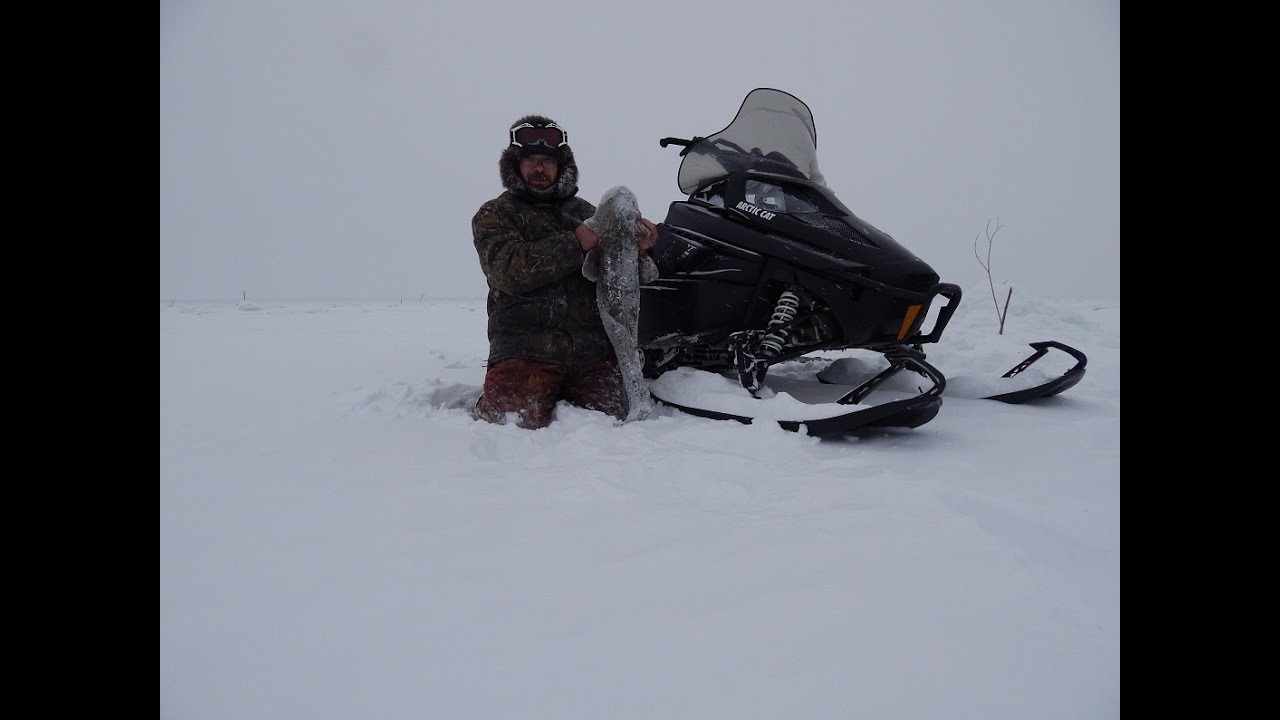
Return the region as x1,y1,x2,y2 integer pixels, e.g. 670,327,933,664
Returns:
582,184,658,423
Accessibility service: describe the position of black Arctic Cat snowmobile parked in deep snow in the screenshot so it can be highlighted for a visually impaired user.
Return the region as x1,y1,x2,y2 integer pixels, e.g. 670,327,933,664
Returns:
639,83,1087,436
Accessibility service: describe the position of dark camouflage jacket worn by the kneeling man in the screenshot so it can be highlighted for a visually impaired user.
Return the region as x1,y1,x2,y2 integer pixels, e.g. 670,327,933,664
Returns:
471,191,613,365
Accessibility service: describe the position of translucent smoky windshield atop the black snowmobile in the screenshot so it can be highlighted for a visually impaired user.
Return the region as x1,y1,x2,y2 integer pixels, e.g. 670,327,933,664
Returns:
676,87,826,195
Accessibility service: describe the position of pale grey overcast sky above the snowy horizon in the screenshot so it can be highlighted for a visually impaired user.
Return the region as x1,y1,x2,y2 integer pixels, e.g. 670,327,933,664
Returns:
160,0,1120,300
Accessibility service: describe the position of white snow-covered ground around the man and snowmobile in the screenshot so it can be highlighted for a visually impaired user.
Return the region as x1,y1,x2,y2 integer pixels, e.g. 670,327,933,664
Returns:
160,286,1120,720
